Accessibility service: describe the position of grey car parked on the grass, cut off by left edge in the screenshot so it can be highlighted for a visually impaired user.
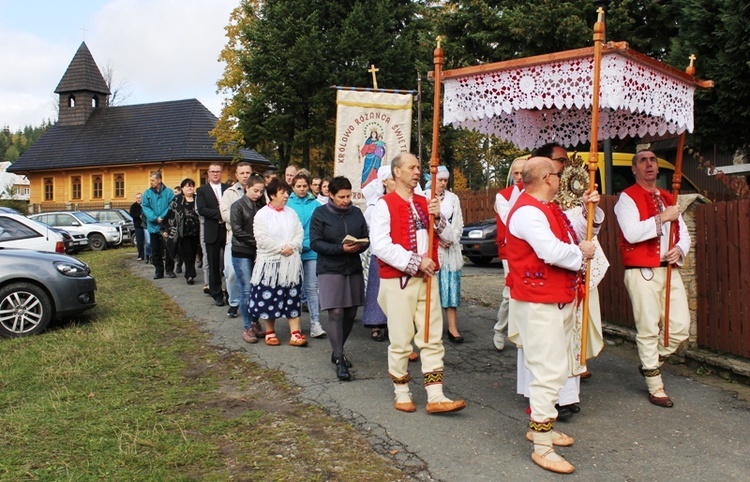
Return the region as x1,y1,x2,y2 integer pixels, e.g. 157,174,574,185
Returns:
0,248,96,337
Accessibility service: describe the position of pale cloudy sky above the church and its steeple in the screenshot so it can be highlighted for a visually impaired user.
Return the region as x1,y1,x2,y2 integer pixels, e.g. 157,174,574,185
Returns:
0,0,239,131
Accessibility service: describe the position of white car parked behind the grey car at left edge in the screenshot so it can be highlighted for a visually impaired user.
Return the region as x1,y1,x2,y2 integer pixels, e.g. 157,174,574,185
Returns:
0,213,65,253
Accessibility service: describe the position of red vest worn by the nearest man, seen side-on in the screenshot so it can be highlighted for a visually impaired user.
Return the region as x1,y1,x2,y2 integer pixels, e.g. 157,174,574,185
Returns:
505,193,580,303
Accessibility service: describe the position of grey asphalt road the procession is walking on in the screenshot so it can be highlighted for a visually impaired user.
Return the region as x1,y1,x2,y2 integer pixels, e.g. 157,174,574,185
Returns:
130,256,750,481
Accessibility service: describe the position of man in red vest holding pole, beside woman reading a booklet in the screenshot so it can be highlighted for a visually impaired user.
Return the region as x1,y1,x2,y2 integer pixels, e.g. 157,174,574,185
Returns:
370,153,466,413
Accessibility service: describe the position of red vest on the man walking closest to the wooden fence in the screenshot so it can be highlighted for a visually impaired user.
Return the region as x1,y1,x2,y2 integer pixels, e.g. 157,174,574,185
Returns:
620,184,680,268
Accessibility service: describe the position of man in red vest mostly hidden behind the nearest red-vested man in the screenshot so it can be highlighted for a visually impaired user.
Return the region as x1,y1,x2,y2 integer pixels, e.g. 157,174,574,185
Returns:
492,157,526,350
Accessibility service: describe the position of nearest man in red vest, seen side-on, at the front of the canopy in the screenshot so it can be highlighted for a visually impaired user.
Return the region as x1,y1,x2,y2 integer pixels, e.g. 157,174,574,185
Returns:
506,157,594,474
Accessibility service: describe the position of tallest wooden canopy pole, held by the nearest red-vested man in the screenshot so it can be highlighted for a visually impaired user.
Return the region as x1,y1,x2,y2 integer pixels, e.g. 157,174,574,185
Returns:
579,7,604,368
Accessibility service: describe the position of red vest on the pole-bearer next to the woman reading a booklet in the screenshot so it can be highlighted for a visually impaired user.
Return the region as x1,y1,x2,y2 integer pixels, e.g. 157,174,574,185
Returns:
378,191,440,278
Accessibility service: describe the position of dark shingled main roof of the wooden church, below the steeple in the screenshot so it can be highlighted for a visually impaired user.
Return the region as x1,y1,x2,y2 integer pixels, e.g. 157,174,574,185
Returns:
8,99,270,172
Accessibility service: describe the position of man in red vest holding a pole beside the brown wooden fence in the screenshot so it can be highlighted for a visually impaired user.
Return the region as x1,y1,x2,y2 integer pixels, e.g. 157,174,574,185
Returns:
615,151,690,407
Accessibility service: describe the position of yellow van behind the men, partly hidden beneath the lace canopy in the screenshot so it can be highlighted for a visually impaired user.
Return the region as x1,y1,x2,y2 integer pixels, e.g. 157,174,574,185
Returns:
505,151,700,194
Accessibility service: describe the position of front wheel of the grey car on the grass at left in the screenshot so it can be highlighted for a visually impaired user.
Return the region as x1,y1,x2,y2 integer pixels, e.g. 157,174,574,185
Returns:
0,283,52,338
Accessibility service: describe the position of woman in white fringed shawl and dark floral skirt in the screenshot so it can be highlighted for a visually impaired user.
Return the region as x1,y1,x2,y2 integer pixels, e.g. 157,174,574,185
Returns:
248,178,307,346
